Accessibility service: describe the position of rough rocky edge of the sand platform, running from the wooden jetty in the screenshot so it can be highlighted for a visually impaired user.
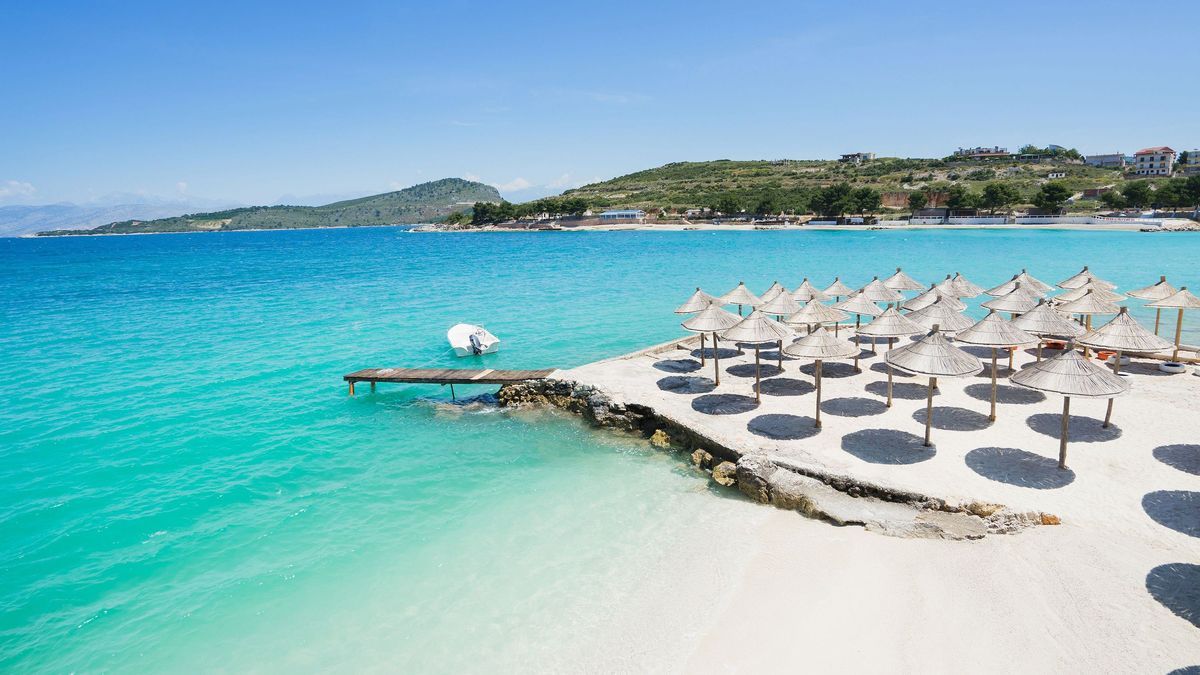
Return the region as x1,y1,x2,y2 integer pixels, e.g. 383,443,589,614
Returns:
496,380,1060,539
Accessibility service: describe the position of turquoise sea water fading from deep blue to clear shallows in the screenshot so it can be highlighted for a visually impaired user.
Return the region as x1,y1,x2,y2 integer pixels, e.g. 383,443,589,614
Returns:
0,228,1200,671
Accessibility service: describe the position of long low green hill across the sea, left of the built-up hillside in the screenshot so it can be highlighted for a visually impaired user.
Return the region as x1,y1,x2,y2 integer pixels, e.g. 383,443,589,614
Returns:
40,178,502,235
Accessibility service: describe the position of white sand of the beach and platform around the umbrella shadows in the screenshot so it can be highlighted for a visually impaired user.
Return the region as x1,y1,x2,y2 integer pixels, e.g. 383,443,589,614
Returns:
560,336,1200,673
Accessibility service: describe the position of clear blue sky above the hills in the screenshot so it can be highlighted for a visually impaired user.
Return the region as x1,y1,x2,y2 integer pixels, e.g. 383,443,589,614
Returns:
0,0,1200,204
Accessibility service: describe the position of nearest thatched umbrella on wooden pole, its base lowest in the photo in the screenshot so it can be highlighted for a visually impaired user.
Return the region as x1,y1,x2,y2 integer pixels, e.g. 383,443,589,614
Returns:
1009,345,1129,468
